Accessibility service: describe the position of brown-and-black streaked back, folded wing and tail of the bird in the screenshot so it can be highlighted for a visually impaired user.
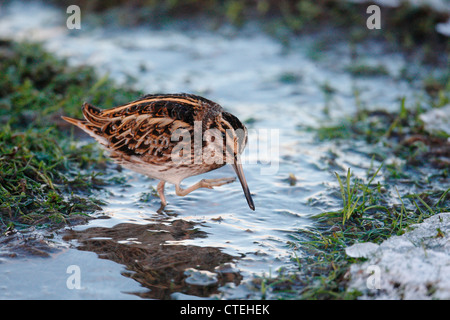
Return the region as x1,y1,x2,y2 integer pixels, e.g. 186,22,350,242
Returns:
64,94,221,163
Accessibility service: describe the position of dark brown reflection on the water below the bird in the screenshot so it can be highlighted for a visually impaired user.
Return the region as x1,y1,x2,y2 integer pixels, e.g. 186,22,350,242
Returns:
64,219,241,299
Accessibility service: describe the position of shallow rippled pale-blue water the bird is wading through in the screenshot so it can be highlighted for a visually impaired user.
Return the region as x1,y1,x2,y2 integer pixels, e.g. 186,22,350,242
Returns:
0,3,436,299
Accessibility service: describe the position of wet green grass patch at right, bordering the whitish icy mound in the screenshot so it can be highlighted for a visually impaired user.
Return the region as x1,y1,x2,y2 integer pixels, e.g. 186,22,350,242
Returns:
291,81,450,299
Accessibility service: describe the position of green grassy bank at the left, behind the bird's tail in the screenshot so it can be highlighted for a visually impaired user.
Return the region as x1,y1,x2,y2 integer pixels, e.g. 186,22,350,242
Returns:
0,41,142,234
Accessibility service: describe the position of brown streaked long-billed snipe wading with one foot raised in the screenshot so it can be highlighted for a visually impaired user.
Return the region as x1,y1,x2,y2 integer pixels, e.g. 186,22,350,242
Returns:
62,94,255,210
